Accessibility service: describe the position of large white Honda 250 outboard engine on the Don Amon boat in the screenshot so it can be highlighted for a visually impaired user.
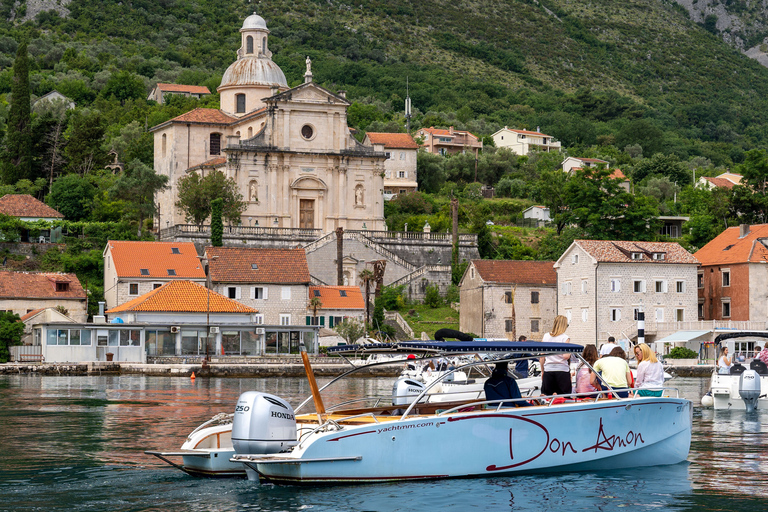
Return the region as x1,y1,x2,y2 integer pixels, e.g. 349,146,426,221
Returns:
232,391,298,455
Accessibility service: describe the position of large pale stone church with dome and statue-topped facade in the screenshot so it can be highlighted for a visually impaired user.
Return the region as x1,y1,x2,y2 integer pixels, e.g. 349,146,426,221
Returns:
151,13,387,233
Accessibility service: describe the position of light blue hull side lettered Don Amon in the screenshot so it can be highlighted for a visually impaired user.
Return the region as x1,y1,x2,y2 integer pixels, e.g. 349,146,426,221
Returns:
236,397,692,483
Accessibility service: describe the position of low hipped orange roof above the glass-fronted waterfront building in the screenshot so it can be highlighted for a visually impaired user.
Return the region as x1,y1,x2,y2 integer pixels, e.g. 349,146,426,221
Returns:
106,280,258,314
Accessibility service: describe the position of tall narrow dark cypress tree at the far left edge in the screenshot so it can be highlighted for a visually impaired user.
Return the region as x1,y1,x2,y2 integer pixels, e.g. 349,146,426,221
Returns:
2,40,32,185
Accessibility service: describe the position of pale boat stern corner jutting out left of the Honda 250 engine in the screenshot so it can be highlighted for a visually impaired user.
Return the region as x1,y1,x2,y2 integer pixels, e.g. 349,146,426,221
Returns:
144,413,245,476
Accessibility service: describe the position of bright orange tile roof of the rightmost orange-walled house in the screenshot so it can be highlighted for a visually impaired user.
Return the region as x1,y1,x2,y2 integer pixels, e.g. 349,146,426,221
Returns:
694,224,768,265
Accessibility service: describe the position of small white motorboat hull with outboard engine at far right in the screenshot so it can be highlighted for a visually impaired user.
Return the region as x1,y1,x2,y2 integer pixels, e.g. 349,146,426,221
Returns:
701,369,768,411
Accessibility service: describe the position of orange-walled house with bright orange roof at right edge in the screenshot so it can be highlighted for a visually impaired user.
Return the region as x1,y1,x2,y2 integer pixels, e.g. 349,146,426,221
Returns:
694,224,768,322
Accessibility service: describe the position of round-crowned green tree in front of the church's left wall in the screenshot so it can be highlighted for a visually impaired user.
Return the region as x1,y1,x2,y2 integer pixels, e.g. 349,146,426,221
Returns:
176,171,246,226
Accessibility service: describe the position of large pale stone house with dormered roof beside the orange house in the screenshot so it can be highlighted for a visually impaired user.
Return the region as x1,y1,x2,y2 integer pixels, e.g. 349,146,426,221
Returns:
555,240,699,345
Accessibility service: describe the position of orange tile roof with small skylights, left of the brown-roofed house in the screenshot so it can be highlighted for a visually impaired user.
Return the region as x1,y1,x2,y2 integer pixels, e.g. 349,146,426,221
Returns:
107,240,205,279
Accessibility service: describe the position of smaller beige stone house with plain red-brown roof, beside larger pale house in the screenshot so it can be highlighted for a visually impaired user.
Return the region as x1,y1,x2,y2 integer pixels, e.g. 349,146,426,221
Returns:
459,260,557,340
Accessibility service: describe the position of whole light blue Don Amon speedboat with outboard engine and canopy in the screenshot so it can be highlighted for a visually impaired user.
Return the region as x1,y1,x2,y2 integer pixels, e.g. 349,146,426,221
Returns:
226,341,692,483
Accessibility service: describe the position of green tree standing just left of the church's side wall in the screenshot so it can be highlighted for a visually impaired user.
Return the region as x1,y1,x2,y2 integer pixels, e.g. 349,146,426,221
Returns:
110,158,168,237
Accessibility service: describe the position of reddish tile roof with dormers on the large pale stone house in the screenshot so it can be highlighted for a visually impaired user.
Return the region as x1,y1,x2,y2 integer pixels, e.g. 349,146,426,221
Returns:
574,240,699,265
